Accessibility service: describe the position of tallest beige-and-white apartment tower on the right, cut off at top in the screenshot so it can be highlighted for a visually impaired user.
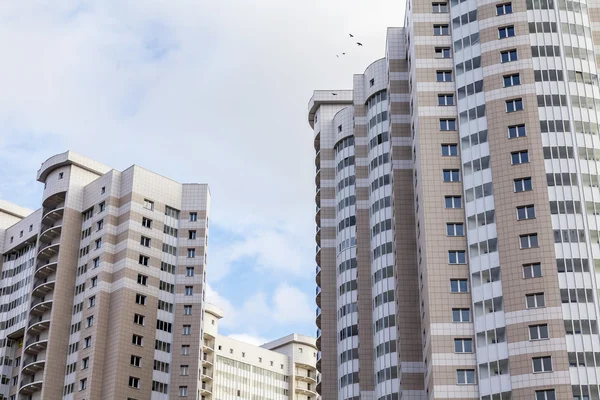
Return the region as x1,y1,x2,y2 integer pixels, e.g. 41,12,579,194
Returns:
308,0,600,400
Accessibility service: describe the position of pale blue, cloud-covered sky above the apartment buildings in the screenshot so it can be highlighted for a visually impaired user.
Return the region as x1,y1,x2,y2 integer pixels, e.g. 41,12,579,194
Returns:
0,0,404,344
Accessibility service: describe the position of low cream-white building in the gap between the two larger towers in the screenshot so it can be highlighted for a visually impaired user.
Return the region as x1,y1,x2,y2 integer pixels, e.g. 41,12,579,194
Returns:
201,304,320,400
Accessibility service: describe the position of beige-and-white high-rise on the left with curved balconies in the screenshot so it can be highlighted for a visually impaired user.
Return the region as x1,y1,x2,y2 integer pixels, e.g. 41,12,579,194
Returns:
0,152,210,400
